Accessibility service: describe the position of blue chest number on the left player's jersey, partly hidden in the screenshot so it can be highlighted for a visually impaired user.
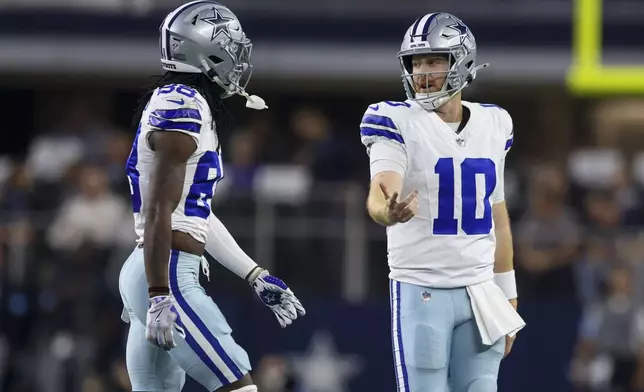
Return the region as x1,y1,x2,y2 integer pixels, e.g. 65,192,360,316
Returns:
184,151,223,219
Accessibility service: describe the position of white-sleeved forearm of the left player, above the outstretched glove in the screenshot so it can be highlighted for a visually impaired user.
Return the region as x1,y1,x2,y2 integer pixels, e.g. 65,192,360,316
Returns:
205,212,257,279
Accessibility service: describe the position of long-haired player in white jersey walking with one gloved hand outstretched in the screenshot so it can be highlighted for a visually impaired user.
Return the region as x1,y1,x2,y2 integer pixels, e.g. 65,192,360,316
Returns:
119,1,304,392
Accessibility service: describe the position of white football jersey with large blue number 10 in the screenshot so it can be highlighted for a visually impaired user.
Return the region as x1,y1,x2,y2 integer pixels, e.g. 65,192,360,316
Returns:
360,101,514,288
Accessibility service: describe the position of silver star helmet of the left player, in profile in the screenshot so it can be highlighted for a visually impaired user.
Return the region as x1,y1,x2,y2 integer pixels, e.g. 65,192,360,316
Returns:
159,1,253,98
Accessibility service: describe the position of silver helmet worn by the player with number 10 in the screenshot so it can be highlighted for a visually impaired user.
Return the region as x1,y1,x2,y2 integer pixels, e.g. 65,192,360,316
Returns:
398,12,489,110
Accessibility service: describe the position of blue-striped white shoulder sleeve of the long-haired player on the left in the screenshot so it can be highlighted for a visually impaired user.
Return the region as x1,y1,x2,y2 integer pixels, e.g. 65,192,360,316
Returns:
145,85,203,146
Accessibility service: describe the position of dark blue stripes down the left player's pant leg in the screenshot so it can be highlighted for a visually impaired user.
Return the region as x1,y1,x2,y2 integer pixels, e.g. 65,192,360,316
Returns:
170,250,244,385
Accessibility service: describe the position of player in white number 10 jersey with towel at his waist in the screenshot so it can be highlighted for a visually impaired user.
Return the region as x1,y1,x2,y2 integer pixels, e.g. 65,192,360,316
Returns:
360,13,525,392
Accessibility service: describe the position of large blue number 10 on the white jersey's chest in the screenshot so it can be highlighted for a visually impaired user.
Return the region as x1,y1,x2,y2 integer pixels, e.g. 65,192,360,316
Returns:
433,158,496,235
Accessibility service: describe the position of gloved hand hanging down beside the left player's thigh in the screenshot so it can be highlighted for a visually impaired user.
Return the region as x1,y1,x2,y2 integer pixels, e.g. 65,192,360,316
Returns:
145,295,185,350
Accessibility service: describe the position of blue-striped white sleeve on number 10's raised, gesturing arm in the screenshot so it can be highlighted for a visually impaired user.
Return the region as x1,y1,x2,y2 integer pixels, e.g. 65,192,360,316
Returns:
360,104,407,178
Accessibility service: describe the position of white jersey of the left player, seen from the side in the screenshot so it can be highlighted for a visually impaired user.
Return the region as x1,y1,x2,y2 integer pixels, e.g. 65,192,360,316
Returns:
126,84,224,243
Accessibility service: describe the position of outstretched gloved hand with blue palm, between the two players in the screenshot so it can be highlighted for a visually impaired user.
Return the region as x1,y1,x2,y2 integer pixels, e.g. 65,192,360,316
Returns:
248,267,306,328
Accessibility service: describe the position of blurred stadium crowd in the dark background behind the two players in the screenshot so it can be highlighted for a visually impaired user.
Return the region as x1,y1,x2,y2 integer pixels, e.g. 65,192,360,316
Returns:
0,2,644,392
